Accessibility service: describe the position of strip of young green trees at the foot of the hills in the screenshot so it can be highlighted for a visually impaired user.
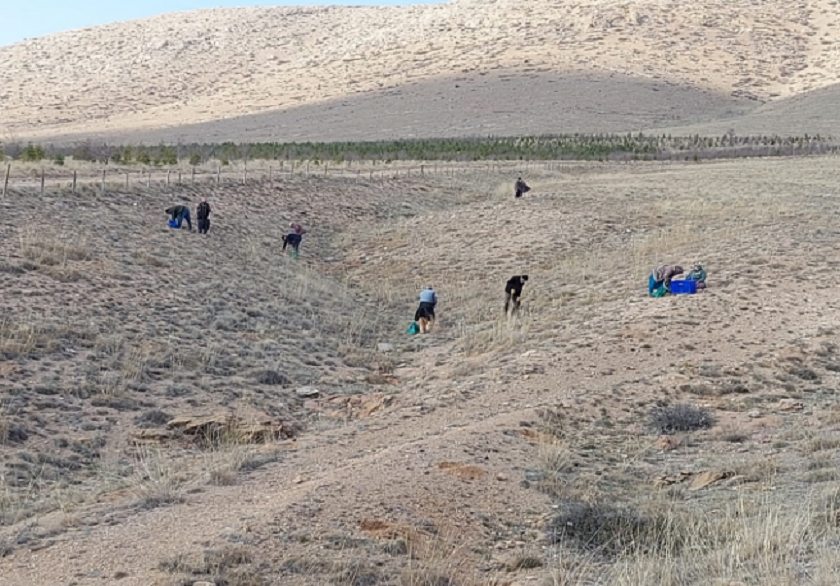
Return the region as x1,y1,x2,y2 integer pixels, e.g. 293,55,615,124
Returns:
0,132,840,166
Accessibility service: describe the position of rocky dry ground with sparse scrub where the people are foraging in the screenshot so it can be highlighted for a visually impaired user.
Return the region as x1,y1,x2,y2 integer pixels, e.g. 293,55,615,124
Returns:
0,158,840,586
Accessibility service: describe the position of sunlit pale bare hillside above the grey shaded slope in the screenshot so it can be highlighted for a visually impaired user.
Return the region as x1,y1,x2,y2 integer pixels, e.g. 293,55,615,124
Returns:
0,0,840,140
